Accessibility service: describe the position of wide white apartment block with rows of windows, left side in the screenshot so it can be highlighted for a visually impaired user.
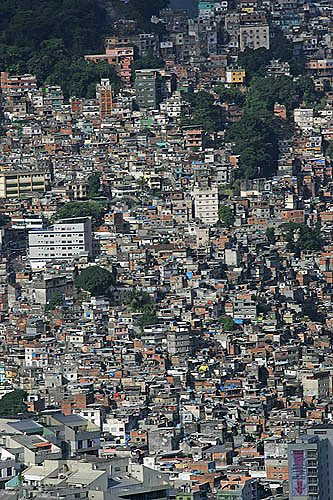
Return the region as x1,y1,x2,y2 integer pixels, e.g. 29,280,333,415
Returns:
29,217,93,267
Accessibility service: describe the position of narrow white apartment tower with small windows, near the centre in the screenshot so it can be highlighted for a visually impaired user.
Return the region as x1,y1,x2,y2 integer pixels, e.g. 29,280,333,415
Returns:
192,186,219,224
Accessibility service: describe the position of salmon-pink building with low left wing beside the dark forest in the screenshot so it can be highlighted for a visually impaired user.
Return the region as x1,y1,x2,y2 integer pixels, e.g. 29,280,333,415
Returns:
84,47,134,83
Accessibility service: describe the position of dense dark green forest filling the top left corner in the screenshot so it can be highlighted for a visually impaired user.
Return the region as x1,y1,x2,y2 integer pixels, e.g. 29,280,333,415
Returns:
0,0,120,98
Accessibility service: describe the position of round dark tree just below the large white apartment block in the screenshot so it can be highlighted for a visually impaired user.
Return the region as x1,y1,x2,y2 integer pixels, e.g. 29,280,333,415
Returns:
74,266,114,295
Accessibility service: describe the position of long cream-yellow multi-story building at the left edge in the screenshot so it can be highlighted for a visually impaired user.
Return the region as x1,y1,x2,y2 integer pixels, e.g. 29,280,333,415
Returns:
0,170,50,198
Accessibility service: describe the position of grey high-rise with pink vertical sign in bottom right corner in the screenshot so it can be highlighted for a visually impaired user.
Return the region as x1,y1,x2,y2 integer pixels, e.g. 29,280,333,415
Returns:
288,435,332,500
